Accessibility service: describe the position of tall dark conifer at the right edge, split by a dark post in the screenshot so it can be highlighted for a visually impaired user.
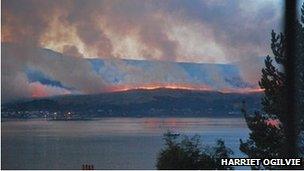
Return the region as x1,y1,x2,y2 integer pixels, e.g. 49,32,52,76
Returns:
240,3,304,169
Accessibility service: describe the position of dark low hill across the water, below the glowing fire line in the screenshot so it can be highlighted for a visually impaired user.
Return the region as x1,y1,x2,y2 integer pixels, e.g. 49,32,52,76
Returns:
1,89,261,118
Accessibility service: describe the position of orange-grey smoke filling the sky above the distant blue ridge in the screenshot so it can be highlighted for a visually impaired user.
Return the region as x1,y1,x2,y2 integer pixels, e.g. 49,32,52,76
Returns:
2,0,282,62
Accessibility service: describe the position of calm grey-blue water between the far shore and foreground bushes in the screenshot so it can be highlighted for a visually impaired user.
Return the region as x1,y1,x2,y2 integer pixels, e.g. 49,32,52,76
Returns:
1,118,248,169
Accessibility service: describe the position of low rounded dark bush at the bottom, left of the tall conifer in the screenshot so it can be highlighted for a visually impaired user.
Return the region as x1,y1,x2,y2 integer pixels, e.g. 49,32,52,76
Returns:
156,132,232,170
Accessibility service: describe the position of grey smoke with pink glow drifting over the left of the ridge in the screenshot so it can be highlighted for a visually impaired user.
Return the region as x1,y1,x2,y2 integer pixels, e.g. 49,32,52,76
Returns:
1,43,106,101
